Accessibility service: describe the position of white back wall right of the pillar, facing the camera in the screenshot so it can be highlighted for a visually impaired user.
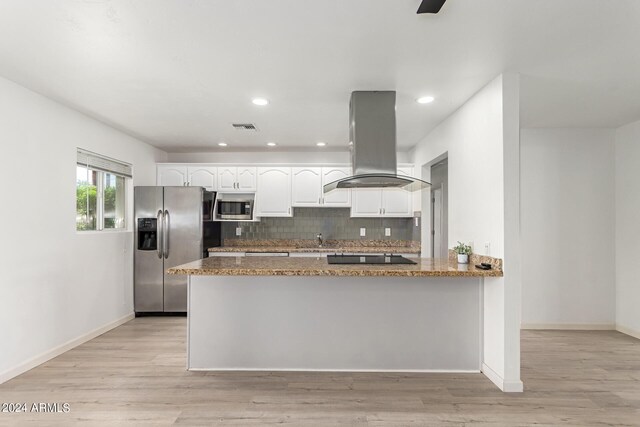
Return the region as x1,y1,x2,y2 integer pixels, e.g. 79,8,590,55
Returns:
521,129,616,329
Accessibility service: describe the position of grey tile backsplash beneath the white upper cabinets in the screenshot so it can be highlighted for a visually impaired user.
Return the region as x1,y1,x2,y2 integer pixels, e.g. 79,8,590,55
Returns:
222,208,421,244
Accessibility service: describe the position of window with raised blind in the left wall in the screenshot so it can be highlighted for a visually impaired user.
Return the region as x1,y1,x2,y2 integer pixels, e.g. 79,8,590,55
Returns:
76,149,132,231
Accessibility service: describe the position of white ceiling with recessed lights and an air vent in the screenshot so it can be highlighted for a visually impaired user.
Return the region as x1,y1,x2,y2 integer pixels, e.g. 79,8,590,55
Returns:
0,0,640,152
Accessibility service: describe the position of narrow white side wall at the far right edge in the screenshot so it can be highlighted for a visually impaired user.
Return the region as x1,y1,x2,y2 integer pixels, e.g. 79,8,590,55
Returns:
615,121,640,338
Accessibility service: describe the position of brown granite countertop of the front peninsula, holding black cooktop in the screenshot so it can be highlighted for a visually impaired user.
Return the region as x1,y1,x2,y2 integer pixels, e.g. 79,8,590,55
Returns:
167,257,503,277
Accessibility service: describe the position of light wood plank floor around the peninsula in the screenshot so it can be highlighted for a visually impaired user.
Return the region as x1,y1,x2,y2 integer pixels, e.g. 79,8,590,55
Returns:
0,318,640,426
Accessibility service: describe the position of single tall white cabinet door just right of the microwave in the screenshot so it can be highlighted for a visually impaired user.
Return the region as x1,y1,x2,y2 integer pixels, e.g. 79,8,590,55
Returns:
255,168,292,217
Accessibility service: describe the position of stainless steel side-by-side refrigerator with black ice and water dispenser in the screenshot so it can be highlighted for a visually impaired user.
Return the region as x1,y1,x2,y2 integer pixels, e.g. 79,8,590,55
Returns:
134,187,204,313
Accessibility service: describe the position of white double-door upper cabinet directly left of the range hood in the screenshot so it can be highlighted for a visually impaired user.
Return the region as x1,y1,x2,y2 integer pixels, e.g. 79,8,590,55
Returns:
292,167,351,208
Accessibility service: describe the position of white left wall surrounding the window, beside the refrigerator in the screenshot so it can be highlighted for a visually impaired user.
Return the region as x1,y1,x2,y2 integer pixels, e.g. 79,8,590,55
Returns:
0,78,166,382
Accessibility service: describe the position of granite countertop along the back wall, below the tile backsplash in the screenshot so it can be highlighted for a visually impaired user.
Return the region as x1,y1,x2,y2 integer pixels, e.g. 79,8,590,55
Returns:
209,239,420,254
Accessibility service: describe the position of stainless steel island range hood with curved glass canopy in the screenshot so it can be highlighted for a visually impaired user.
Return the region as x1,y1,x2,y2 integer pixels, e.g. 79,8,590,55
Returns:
323,91,431,193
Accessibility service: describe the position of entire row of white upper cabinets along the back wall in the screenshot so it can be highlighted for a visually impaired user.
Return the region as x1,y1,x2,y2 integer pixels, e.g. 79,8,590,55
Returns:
156,163,412,218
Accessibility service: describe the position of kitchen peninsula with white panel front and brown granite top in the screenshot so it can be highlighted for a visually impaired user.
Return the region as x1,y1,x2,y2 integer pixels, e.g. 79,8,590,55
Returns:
168,256,502,372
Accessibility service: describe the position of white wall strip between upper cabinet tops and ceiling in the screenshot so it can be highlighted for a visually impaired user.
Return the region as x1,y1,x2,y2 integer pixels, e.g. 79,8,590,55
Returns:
167,149,411,163
